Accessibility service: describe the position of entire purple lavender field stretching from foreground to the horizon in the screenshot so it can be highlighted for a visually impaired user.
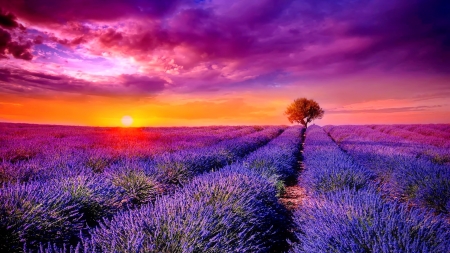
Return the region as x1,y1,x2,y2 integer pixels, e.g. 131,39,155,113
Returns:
0,124,450,253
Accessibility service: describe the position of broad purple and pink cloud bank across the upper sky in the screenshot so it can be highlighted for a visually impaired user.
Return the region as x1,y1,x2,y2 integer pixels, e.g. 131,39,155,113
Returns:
0,0,450,95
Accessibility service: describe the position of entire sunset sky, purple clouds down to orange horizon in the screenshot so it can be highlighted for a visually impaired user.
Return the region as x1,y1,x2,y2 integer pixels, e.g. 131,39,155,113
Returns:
0,0,450,126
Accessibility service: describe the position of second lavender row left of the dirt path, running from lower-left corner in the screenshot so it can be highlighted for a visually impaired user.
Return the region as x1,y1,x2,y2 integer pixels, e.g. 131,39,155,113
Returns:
0,127,284,252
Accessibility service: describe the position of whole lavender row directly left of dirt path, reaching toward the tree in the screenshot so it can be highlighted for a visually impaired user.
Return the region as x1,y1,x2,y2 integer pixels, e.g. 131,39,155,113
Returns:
29,127,303,253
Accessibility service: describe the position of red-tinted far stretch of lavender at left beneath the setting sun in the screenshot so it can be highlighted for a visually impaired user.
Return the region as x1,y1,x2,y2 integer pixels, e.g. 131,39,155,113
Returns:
0,124,262,182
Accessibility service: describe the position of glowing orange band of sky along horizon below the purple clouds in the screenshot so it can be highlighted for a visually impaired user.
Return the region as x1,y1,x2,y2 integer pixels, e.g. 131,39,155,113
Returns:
0,73,450,127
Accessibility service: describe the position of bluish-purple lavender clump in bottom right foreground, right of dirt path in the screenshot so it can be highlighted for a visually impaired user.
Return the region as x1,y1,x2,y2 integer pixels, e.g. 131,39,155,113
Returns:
292,189,450,253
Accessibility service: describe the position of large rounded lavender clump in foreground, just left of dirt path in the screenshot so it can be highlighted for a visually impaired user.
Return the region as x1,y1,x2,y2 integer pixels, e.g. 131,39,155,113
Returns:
91,167,286,252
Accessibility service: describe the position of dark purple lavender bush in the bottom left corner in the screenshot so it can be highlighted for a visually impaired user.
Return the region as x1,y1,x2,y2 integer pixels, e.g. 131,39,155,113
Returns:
0,182,84,252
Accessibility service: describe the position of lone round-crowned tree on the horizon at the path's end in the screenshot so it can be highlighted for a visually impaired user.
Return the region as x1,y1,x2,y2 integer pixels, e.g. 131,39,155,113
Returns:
284,98,325,127
